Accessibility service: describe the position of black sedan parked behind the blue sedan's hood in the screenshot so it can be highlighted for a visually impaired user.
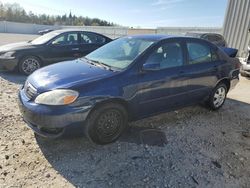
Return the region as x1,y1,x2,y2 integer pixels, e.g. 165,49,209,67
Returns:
0,29,112,75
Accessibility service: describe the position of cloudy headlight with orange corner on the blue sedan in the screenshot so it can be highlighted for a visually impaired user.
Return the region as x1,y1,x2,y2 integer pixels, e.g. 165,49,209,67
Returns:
35,89,79,105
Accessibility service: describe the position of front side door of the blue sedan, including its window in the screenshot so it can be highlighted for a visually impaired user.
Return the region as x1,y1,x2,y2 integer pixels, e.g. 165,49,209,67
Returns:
138,42,188,117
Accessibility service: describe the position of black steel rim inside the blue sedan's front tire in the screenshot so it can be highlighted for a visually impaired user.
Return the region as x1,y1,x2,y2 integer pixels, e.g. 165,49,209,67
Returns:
96,109,123,139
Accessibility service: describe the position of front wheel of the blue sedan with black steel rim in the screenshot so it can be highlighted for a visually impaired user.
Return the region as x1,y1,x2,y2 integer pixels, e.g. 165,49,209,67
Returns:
85,103,128,145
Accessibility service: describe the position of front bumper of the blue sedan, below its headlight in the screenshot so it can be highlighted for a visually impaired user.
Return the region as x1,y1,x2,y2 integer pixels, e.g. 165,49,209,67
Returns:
18,89,91,138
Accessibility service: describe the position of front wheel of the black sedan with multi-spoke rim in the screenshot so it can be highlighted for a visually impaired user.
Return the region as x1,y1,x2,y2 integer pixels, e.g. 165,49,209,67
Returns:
18,56,42,76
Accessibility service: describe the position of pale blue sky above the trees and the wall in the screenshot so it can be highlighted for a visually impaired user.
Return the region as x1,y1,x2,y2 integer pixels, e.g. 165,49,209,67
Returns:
0,0,227,28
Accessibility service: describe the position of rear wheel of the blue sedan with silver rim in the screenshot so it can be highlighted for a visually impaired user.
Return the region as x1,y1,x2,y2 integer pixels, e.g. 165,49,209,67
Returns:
208,83,229,110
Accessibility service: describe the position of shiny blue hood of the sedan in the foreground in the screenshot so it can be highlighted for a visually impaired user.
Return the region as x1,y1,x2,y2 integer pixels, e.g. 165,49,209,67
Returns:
28,59,116,93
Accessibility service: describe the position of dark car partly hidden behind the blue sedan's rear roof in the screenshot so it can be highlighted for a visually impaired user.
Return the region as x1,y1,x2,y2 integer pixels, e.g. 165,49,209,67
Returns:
186,32,227,47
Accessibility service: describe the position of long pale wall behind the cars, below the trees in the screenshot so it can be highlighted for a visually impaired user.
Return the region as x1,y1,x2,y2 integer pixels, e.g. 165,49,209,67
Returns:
0,21,222,38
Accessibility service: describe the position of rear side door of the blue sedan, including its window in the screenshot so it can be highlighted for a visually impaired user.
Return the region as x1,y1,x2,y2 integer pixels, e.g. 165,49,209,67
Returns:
182,39,221,102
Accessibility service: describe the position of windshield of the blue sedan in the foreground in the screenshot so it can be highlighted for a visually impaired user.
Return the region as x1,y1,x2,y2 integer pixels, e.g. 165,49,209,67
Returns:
86,37,154,69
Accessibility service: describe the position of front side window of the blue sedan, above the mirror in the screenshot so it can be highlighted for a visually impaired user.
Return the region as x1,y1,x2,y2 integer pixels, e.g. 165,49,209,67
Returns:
146,43,183,69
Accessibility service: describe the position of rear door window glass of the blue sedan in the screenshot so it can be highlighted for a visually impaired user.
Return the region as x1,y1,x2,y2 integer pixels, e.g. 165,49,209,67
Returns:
187,42,212,64
